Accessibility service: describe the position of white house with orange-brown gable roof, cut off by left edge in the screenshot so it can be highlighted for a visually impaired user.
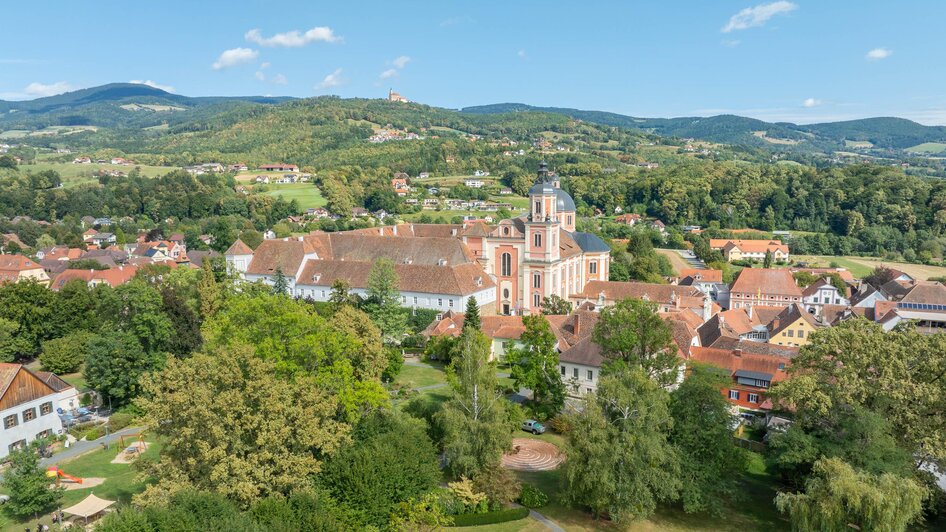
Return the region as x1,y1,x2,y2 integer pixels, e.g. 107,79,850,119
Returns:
0,363,74,458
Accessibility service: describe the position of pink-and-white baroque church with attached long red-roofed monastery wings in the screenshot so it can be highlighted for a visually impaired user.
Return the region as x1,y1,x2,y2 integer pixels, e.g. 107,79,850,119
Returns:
225,162,610,315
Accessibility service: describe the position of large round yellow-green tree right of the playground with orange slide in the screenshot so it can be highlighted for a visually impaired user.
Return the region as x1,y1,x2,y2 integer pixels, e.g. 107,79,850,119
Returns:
136,345,349,507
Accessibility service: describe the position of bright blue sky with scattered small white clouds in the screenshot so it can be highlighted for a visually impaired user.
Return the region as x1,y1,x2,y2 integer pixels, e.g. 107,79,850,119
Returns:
0,0,946,125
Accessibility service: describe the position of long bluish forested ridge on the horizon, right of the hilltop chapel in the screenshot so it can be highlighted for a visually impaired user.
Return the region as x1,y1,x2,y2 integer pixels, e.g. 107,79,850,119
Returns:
462,103,946,151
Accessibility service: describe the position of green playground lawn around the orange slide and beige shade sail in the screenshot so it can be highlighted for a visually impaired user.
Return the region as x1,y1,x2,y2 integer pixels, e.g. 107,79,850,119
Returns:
0,438,160,531
